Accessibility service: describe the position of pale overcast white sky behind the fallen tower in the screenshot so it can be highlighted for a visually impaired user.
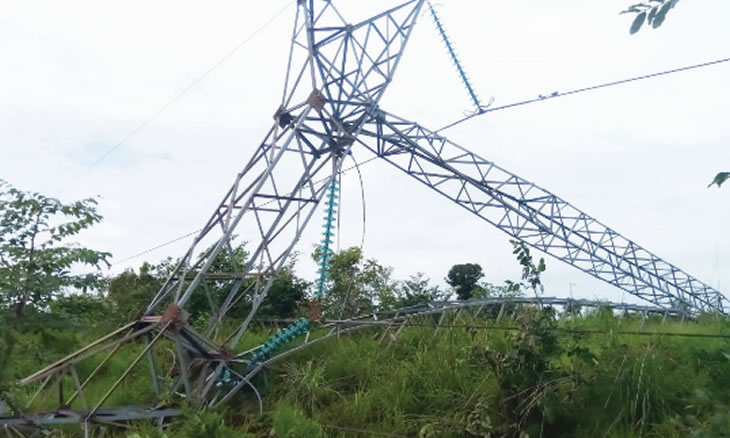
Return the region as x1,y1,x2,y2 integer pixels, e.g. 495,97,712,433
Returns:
0,0,730,301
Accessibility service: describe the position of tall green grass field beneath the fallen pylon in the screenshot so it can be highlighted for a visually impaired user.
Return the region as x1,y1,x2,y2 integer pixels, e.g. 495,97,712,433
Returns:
5,308,730,438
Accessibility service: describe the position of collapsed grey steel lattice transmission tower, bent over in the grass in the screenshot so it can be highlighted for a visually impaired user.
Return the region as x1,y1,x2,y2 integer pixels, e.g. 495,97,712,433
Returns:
0,0,730,434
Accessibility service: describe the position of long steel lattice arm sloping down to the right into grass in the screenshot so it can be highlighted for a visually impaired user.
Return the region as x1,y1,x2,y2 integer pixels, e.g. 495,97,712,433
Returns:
358,111,730,313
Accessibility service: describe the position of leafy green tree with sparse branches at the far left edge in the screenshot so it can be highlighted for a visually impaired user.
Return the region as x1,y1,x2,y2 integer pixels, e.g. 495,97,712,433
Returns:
0,181,111,317
